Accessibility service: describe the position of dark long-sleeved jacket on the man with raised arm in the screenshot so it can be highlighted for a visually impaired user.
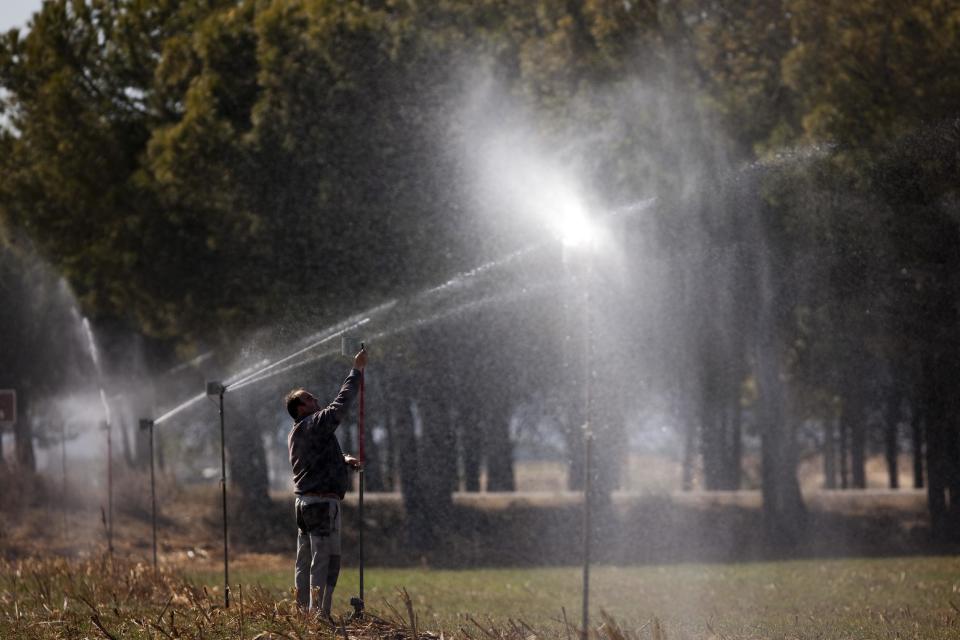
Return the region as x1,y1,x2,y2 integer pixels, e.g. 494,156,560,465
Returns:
287,369,360,500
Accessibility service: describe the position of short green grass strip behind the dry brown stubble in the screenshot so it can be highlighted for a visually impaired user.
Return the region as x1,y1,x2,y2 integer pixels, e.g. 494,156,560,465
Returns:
189,557,960,638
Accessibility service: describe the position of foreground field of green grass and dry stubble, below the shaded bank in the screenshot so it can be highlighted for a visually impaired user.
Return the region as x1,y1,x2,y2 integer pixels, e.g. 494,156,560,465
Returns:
0,556,960,640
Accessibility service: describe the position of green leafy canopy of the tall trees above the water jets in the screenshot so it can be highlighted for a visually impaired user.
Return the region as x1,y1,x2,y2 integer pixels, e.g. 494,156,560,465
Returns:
0,0,960,536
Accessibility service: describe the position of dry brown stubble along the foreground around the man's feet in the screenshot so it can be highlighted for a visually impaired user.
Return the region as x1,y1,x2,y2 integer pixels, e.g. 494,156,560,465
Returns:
0,556,663,640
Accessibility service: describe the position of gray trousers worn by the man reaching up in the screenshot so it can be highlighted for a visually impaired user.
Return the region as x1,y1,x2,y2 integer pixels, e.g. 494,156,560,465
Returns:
293,496,340,616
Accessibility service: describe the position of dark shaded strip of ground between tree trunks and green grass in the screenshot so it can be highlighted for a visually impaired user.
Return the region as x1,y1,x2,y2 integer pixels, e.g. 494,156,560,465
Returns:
229,492,960,568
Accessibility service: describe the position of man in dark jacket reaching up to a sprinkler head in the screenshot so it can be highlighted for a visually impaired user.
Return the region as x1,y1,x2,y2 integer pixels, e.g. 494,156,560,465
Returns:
285,349,367,619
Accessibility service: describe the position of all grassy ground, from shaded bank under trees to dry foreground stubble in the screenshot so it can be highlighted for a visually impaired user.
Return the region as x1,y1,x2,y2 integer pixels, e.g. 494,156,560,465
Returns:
0,483,960,640
